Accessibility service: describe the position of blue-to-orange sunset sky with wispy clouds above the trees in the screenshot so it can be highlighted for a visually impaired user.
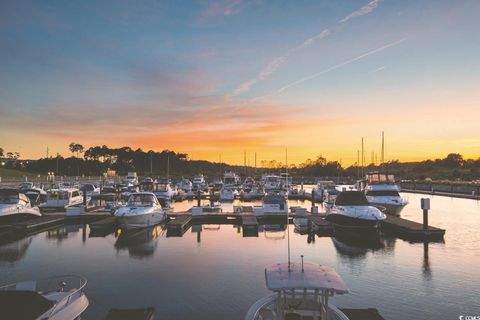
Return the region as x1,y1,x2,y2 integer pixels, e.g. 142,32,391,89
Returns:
0,0,480,165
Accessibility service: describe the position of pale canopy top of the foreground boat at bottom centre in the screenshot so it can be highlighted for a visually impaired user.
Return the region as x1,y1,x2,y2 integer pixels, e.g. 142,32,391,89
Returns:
265,263,348,294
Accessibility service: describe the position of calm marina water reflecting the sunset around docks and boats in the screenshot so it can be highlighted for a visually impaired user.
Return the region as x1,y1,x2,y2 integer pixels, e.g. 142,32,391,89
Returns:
0,194,480,320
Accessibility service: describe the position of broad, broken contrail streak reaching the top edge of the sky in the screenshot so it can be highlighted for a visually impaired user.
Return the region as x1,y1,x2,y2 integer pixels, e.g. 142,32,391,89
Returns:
232,0,382,96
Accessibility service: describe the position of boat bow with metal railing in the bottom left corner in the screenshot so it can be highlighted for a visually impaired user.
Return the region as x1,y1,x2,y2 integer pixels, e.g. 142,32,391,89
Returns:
0,275,89,320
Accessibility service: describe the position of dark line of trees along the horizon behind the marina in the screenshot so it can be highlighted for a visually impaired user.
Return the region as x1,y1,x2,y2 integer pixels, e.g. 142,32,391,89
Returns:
0,142,480,181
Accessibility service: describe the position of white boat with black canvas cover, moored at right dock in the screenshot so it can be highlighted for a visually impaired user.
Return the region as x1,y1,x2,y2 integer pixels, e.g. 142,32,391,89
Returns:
326,191,386,235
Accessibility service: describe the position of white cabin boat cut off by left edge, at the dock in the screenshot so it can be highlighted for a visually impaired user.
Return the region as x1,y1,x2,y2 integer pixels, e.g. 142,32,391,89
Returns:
0,189,41,224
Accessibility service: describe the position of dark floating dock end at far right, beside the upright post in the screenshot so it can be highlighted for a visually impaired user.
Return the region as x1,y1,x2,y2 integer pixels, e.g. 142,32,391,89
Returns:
382,215,445,241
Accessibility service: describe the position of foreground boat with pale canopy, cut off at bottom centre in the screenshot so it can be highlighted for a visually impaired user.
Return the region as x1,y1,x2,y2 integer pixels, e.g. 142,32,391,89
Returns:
245,261,348,320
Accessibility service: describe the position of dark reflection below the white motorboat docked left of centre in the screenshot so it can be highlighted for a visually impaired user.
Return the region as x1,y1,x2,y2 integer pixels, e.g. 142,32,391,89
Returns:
114,225,165,259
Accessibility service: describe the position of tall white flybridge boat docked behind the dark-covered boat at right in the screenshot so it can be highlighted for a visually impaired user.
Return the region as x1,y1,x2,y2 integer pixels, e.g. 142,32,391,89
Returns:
365,173,408,216
